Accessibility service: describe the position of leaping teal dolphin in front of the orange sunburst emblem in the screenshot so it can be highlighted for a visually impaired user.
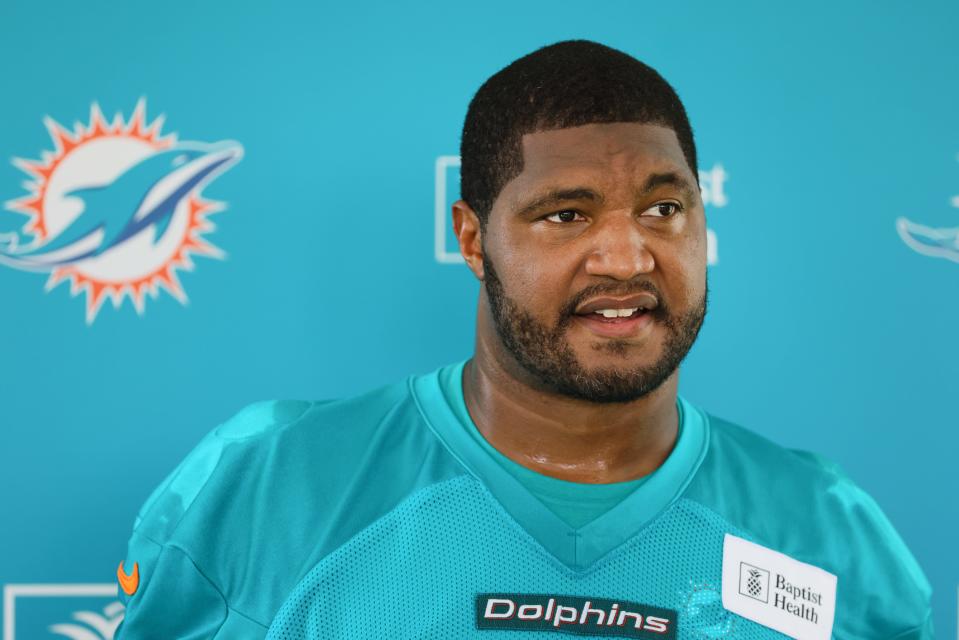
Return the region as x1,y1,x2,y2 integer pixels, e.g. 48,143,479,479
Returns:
0,141,243,271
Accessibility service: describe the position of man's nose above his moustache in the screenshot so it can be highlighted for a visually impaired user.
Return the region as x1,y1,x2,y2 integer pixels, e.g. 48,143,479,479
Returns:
586,213,656,280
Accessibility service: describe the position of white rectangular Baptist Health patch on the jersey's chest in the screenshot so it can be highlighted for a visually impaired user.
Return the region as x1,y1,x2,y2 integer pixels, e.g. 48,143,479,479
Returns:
723,533,836,640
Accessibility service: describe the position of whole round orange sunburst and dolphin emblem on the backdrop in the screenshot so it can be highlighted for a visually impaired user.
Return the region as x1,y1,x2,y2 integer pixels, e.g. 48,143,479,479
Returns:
0,100,243,324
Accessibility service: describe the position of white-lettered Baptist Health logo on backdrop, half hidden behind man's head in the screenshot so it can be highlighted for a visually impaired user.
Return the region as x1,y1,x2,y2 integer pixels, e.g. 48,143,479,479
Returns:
433,156,729,265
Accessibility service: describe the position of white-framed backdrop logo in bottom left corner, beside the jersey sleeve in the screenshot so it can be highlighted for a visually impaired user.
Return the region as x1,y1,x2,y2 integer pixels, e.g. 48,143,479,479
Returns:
3,584,124,640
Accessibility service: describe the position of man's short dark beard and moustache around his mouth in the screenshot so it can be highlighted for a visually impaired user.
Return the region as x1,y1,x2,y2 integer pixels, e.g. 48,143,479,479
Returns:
483,255,708,403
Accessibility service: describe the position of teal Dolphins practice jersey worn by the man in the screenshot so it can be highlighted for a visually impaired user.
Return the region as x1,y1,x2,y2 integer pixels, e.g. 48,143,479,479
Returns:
116,363,933,640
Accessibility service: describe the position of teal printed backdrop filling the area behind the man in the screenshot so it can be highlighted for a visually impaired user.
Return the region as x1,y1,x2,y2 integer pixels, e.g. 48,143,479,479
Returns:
0,0,959,640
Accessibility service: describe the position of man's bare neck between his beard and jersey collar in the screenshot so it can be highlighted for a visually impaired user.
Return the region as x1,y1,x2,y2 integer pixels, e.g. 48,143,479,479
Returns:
463,340,679,483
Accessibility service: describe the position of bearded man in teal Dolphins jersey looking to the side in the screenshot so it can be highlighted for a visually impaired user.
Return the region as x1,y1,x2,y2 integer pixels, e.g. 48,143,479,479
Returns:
118,41,932,640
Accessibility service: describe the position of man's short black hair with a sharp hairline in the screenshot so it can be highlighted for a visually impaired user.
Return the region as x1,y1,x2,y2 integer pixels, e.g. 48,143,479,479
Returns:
460,40,699,226
